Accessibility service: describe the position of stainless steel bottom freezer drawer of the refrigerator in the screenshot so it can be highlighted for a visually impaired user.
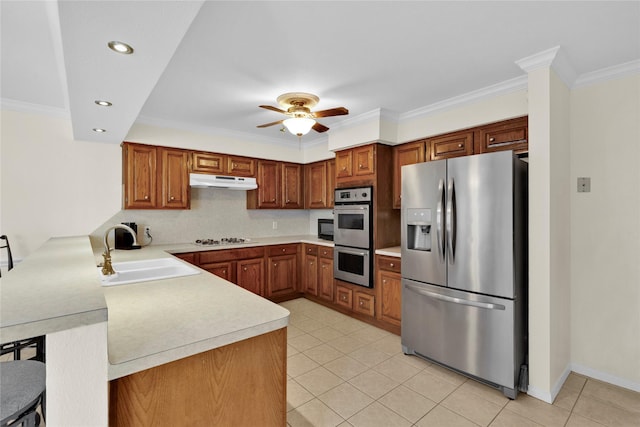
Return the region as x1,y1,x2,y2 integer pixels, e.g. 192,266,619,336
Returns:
402,279,521,397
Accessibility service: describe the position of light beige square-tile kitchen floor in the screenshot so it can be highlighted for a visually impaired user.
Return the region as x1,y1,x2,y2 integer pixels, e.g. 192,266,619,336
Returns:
281,298,640,427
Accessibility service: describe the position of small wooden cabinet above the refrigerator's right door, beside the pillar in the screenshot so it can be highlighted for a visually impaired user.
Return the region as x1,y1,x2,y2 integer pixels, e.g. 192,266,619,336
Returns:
474,117,529,154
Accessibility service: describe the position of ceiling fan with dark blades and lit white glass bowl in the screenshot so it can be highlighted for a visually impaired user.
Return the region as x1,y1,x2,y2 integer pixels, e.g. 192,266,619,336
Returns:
257,92,349,137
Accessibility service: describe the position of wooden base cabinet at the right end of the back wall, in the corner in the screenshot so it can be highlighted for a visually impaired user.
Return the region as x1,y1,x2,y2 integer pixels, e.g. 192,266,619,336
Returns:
266,244,300,298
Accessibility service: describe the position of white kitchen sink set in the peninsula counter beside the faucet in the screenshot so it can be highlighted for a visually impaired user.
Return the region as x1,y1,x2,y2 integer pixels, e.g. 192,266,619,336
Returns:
98,258,200,286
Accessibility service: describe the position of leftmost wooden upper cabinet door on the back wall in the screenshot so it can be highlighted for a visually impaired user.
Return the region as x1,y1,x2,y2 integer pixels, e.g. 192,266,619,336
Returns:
124,144,157,209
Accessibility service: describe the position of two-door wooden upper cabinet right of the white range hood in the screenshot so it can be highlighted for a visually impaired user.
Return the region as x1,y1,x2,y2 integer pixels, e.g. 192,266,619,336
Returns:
247,160,304,209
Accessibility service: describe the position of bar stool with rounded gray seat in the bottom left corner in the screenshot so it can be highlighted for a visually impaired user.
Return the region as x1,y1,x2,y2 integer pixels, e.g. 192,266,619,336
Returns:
0,360,46,427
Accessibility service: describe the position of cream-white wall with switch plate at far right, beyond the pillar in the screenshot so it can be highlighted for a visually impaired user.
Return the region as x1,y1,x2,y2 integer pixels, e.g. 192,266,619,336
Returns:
570,74,640,391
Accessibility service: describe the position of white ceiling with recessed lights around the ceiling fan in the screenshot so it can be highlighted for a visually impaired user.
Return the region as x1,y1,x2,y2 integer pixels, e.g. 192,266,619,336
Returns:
0,0,640,145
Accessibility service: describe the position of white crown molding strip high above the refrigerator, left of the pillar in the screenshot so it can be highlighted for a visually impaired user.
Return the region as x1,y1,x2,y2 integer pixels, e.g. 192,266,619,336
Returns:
399,76,528,121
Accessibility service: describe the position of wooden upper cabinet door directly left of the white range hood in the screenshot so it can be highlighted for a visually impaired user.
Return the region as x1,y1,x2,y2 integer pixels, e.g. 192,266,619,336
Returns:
158,148,190,209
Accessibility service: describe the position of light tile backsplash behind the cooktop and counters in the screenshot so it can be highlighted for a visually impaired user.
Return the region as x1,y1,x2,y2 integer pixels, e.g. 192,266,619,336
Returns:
91,188,333,244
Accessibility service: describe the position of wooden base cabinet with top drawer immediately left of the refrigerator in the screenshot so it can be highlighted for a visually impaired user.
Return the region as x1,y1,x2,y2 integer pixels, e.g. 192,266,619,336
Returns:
376,255,402,326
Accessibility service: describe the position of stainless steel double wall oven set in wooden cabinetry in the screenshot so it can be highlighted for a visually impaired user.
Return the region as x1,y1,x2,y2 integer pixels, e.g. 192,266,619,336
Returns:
333,187,373,288
